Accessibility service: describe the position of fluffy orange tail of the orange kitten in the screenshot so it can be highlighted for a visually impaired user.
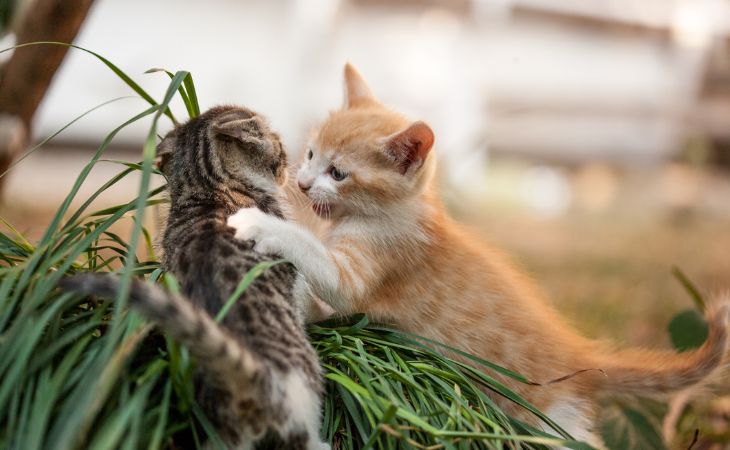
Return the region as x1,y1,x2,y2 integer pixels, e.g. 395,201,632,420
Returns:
599,298,730,395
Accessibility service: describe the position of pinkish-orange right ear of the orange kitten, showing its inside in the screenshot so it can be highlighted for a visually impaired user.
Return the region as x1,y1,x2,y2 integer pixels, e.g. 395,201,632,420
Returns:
385,121,435,175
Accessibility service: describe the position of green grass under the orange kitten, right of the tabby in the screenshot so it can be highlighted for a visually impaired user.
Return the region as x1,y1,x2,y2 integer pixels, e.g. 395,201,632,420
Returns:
310,316,588,449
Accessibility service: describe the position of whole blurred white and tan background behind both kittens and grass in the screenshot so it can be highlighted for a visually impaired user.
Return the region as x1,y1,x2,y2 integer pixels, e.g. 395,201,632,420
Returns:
0,0,730,346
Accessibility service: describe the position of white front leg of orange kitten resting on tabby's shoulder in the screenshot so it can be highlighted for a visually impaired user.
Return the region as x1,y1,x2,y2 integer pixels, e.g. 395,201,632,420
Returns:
228,208,366,313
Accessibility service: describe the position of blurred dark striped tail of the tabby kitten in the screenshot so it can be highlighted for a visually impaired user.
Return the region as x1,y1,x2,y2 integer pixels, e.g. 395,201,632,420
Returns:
59,274,263,389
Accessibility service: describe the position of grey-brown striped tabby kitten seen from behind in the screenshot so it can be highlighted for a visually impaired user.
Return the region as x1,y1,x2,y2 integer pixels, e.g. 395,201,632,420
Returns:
65,106,329,450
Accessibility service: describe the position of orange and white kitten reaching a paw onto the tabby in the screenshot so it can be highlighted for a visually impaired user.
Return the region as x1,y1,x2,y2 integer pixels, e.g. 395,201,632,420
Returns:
229,64,730,445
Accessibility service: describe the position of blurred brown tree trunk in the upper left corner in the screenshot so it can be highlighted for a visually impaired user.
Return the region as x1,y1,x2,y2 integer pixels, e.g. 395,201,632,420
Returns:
0,0,93,187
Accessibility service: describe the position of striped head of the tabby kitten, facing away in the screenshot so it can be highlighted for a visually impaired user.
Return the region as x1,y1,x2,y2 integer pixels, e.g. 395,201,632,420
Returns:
157,106,286,208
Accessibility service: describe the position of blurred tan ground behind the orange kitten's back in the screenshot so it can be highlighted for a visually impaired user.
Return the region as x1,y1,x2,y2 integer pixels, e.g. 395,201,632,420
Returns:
450,163,730,346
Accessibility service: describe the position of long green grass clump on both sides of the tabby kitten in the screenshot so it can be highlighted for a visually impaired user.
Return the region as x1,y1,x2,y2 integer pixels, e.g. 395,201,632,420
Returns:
0,43,704,450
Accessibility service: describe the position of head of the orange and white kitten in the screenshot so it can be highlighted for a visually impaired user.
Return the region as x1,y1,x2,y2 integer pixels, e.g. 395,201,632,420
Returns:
297,64,435,218
